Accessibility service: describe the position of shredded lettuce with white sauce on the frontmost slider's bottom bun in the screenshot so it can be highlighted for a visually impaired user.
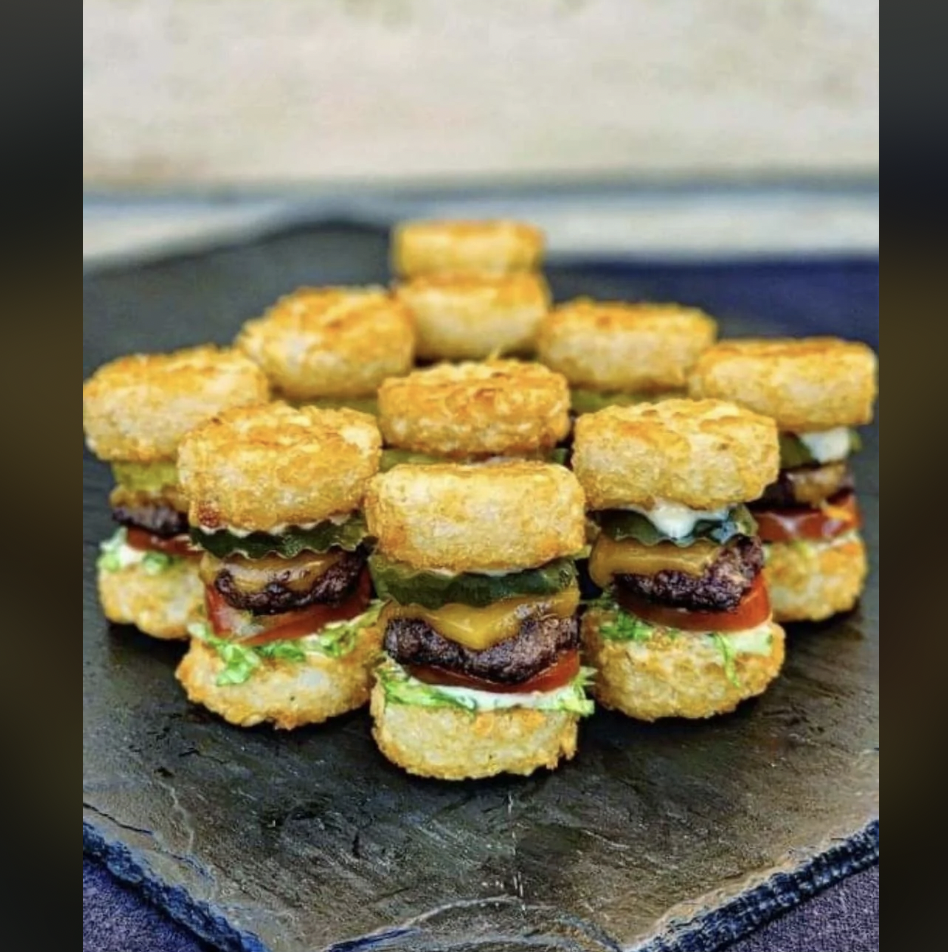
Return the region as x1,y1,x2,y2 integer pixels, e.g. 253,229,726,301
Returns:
376,657,596,717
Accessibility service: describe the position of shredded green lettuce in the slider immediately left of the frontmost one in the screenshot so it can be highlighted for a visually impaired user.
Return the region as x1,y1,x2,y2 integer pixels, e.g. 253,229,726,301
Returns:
188,601,382,687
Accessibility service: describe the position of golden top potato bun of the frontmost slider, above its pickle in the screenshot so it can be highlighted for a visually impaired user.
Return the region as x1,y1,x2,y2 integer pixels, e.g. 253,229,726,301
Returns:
365,462,586,572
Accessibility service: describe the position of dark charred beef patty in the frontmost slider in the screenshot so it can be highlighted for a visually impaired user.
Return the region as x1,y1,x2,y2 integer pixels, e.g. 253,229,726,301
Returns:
385,615,579,684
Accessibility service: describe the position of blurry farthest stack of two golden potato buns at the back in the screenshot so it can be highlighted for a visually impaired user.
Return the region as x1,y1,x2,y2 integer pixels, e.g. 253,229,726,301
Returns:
392,221,551,361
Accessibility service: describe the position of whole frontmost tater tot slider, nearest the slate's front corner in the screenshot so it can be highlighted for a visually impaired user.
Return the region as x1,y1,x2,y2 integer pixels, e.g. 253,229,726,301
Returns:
366,462,592,780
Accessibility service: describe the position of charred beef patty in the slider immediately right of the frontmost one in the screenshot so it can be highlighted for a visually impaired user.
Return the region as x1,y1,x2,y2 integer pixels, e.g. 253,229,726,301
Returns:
616,536,764,611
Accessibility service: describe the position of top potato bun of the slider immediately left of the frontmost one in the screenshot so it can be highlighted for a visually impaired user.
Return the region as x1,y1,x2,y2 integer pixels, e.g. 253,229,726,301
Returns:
178,403,382,532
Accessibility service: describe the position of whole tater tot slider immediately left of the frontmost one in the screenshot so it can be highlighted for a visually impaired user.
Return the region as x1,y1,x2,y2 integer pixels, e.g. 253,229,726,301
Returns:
178,403,382,729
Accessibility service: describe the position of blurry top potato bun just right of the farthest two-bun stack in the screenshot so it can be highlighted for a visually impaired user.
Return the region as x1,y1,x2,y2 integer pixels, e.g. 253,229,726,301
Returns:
537,298,718,393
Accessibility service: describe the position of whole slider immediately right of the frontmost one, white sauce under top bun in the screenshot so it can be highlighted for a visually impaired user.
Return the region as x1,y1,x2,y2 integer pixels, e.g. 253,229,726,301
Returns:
573,400,784,721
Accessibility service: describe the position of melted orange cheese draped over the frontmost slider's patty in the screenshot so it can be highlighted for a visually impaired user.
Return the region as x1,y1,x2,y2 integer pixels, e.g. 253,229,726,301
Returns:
381,586,579,651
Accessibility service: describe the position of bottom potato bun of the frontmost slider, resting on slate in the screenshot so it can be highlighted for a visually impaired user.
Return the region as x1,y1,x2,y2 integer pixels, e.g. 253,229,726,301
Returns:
372,685,579,780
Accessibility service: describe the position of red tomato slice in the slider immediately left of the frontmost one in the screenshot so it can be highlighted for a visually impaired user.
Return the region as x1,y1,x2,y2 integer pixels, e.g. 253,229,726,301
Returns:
205,572,372,646
